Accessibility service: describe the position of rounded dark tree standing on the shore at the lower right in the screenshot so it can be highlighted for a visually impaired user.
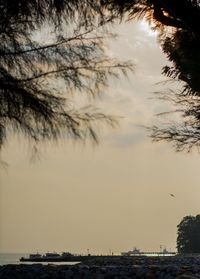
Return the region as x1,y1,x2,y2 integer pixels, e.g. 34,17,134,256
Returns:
177,215,200,254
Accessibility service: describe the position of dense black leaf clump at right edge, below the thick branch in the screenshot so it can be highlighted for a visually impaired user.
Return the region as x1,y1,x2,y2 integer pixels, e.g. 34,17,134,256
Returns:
162,30,200,95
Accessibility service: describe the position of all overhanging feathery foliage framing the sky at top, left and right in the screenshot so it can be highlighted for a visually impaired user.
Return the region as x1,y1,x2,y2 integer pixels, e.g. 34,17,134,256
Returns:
0,0,200,151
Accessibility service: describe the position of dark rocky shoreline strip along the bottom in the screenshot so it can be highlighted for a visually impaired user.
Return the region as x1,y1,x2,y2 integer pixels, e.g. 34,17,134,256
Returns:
0,256,200,279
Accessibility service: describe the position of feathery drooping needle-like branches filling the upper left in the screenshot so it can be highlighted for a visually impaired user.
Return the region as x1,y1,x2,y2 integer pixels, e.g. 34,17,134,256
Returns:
0,0,132,150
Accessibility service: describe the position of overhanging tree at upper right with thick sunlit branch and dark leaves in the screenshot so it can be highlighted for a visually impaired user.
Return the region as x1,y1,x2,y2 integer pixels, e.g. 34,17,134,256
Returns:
103,0,200,151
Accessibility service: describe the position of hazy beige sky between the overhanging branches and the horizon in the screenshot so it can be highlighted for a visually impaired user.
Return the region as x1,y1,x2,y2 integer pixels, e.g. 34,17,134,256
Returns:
0,20,200,253
